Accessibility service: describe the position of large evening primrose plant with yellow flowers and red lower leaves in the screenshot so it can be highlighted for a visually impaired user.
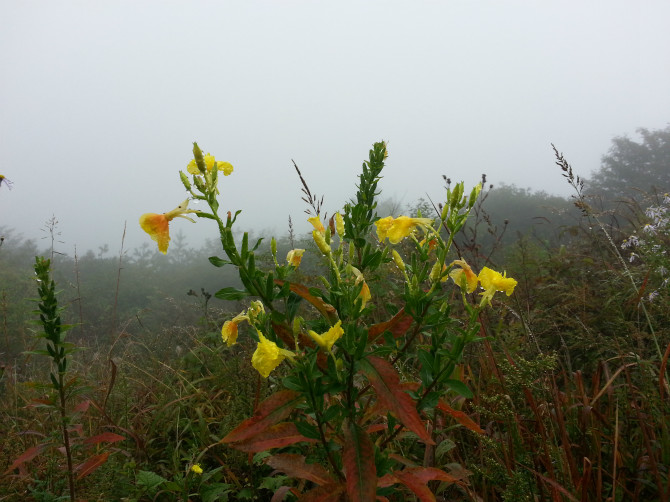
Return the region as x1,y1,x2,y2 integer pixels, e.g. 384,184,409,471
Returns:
140,142,516,501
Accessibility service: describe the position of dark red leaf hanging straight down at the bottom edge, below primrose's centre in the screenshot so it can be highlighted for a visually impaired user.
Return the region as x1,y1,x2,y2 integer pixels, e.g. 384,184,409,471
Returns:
342,424,377,502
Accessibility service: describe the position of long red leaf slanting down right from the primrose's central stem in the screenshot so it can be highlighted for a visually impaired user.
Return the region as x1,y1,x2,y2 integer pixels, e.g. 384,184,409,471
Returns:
361,356,435,444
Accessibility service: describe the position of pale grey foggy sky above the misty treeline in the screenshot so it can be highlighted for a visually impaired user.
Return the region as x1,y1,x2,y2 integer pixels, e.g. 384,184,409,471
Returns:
0,0,670,255
